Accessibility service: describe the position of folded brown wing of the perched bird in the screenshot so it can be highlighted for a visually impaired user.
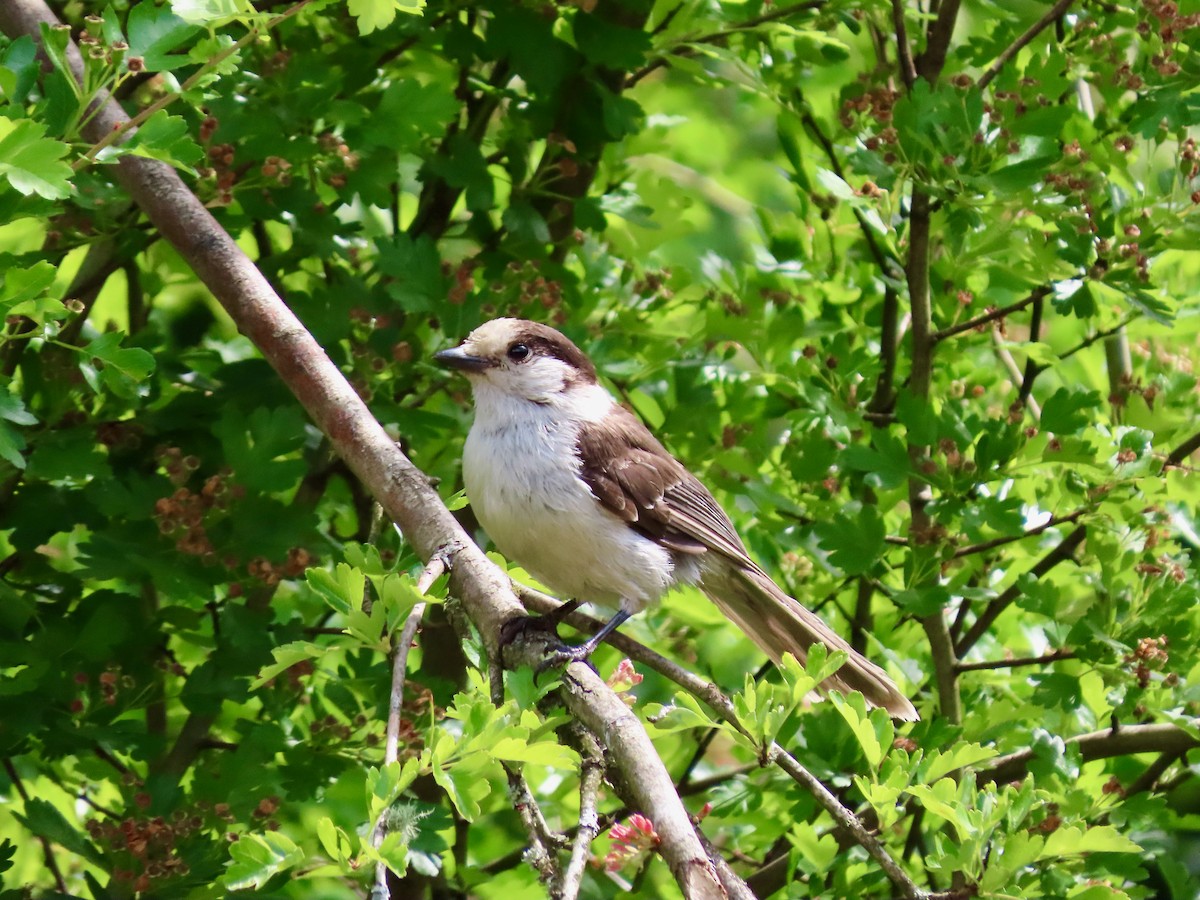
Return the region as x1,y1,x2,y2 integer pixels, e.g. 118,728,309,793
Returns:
578,407,752,565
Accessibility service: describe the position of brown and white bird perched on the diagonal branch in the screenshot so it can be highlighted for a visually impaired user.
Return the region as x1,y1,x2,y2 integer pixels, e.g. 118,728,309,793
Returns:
433,318,919,721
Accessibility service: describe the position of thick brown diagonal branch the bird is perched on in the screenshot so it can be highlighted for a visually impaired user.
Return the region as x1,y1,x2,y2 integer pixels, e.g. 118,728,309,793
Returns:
0,8,725,898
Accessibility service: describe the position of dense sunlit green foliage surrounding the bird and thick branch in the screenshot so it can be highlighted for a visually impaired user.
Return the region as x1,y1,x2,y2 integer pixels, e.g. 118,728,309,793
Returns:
0,0,1200,900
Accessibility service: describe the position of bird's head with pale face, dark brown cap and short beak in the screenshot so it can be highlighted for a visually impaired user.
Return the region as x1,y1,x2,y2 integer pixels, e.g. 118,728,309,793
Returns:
433,319,596,403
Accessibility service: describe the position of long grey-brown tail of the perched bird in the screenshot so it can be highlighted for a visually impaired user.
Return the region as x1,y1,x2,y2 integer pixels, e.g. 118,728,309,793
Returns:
700,560,920,721
